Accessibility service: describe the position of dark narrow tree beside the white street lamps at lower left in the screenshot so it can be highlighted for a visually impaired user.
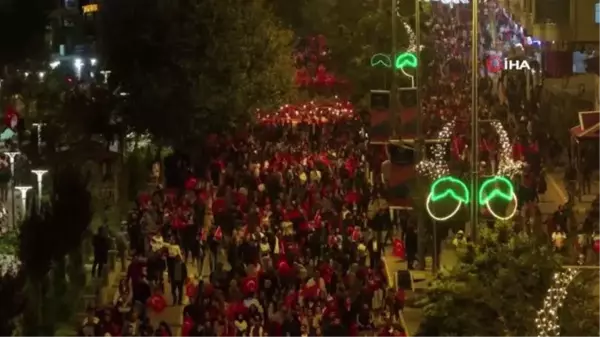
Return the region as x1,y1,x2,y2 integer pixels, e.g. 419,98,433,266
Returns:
19,166,92,336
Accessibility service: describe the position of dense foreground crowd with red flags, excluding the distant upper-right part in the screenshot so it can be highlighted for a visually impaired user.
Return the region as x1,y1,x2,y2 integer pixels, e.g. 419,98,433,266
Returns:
81,120,403,337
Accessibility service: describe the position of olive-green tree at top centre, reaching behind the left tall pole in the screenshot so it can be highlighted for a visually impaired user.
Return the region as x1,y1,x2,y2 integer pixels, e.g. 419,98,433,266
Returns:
271,0,426,100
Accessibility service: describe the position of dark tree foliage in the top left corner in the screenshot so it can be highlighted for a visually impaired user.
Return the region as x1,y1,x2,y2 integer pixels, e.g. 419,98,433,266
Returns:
0,0,57,66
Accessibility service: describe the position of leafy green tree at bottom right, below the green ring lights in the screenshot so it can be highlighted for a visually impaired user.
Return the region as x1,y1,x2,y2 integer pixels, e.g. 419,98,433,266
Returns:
423,224,598,337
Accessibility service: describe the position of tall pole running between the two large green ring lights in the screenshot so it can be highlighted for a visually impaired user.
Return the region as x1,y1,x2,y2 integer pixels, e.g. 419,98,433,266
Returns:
470,0,479,242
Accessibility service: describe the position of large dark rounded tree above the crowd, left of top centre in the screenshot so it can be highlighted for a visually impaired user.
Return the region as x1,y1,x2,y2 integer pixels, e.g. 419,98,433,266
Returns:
100,0,293,146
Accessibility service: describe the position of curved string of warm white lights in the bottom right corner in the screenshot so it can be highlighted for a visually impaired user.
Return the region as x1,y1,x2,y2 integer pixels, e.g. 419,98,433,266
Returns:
535,268,579,337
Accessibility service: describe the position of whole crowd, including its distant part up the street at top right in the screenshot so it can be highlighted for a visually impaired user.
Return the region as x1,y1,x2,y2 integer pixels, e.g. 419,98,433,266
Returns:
76,2,572,337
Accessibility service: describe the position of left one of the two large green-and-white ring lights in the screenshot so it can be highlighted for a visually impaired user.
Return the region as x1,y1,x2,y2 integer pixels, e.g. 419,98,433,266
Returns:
425,176,469,221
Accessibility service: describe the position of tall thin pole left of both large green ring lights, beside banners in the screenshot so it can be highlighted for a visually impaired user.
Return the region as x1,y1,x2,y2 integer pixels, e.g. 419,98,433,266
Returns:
414,0,427,269
